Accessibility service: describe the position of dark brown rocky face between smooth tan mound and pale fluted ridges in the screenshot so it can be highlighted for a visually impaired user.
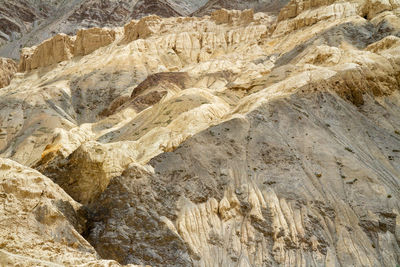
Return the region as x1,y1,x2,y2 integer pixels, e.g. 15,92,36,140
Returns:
84,167,192,266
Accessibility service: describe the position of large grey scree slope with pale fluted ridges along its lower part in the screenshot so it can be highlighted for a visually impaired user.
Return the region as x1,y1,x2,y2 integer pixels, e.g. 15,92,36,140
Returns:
89,90,400,266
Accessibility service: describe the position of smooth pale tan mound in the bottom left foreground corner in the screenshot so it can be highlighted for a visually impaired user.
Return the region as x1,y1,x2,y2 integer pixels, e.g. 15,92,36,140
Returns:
0,159,144,267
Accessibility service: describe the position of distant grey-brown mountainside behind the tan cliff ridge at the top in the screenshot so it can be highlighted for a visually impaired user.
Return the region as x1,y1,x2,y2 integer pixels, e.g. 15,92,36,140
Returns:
0,0,268,59
